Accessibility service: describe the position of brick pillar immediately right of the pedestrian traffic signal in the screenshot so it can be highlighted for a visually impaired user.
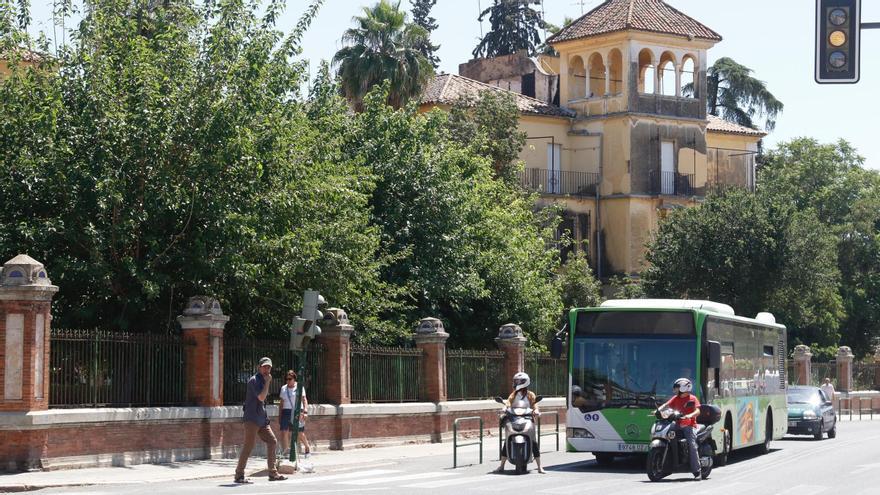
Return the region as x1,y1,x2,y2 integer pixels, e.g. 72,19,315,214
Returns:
318,308,354,405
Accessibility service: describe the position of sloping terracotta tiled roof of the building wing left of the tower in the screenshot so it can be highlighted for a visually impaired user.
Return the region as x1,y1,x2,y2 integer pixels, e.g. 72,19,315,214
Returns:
422,74,575,117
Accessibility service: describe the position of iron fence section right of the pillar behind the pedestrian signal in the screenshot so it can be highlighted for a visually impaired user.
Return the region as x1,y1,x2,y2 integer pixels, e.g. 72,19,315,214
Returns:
350,345,424,403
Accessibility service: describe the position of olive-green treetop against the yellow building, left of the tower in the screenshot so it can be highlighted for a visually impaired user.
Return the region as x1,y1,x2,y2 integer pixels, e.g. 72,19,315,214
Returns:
448,91,527,181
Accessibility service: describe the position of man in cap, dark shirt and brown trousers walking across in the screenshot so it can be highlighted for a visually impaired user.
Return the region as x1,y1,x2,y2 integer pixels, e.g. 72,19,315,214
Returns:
235,357,287,483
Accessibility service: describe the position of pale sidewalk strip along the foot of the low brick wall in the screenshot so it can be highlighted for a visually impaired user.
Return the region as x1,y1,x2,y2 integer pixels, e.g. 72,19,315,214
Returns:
0,442,458,492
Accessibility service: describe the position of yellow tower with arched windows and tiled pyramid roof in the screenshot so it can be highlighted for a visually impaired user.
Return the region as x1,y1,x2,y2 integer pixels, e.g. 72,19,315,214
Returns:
548,0,721,273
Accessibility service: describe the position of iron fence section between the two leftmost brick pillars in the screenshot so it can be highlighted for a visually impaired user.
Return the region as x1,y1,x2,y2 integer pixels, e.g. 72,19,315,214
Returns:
49,328,189,408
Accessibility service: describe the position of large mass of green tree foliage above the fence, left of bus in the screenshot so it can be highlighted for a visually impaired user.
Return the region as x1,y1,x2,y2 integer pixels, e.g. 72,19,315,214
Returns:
0,0,584,346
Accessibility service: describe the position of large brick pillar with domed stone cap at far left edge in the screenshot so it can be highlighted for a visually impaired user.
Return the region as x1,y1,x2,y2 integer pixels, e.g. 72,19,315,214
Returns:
0,254,58,412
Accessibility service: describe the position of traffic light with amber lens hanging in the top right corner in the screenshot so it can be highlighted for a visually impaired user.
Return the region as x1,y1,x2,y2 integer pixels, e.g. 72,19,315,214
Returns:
816,0,862,84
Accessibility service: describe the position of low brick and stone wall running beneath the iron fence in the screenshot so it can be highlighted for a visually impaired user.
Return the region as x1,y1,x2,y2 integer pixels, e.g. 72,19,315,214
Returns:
0,398,565,471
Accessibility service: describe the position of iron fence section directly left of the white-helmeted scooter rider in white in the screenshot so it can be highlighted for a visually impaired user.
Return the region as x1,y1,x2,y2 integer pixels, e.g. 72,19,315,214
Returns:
446,349,510,400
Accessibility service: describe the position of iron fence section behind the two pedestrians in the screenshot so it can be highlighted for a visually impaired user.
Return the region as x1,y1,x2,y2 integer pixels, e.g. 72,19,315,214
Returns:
223,339,327,405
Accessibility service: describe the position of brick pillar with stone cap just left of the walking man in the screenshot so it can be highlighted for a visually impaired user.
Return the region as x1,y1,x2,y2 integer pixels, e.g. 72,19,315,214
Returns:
177,296,229,407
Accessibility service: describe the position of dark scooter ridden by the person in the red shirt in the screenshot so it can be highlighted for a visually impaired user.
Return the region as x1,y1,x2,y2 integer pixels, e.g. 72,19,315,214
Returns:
647,404,721,481
